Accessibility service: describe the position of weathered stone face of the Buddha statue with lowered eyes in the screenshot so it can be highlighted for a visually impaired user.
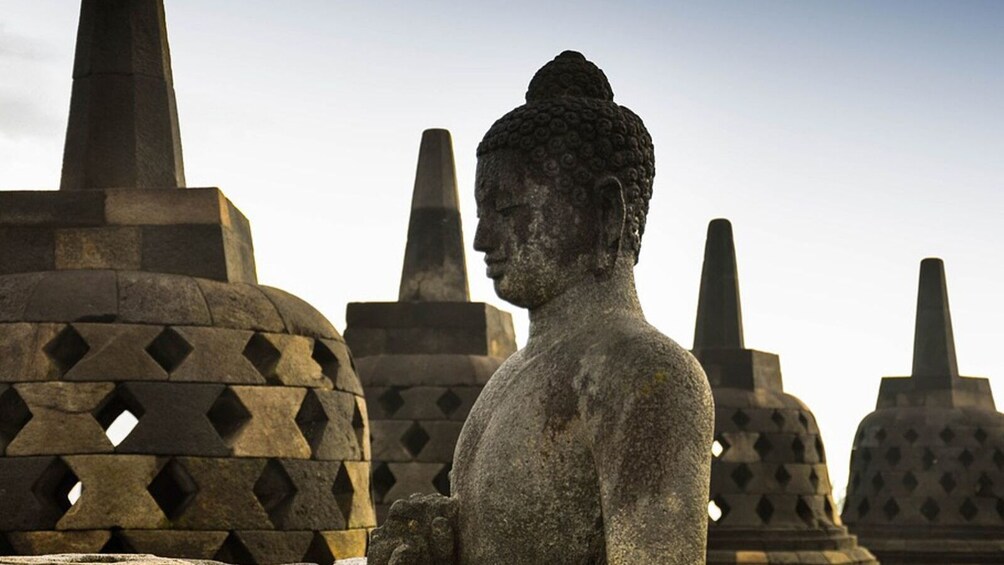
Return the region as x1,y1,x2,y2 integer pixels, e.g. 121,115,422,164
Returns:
474,153,596,308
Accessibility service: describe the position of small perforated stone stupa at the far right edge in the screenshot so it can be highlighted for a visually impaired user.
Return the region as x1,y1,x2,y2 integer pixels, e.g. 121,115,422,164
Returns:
843,259,1004,564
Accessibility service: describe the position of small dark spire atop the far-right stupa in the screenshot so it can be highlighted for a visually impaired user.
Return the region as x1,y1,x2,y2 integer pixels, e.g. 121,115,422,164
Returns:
912,259,959,387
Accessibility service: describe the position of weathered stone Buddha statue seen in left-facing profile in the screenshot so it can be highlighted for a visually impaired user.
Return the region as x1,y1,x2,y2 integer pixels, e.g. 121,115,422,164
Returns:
368,51,714,565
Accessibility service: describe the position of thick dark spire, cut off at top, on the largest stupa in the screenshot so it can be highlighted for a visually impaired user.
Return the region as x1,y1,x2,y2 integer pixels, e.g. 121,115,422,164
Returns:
60,0,185,190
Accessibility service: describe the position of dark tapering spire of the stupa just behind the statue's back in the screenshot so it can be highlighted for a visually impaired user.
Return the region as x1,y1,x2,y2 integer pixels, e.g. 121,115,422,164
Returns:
694,219,745,349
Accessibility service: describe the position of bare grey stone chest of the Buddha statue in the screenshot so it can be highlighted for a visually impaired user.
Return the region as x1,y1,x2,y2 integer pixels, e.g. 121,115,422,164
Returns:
452,343,605,565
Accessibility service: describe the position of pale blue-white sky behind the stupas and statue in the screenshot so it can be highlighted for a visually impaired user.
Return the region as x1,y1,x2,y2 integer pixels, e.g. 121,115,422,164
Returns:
0,0,1004,498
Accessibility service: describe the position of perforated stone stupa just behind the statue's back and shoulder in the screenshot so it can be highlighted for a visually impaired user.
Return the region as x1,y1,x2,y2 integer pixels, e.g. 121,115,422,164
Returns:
693,220,876,565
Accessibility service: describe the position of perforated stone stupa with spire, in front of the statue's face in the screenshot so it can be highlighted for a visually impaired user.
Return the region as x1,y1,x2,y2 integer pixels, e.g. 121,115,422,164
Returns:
345,129,516,521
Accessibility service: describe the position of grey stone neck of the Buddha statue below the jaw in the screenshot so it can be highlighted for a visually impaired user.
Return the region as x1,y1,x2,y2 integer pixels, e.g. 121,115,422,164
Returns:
527,260,645,346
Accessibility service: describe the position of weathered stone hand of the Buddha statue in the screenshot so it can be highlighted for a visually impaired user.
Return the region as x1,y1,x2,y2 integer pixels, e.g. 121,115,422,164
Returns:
367,495,457,565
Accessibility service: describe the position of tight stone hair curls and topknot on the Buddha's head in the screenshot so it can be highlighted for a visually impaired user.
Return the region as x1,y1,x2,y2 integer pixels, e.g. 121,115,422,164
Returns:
478,51,656,260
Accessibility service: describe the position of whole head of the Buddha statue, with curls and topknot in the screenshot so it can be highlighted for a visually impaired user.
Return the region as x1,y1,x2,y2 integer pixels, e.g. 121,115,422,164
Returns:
474,51,656,308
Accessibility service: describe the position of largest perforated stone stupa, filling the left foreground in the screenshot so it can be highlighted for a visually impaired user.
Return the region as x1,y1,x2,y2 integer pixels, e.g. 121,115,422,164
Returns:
0,0,374,563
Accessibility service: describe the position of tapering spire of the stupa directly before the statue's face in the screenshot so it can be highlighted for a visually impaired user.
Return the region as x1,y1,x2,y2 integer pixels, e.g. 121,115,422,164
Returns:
399,129,471,302
